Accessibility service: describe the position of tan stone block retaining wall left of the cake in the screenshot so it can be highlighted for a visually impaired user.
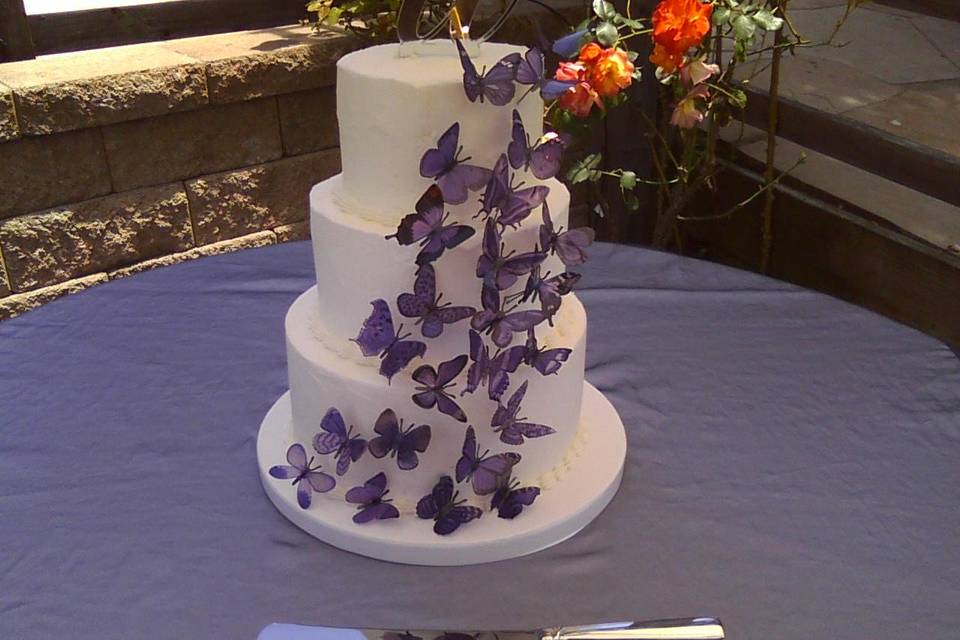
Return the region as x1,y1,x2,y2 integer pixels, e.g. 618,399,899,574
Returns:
0,27,359,319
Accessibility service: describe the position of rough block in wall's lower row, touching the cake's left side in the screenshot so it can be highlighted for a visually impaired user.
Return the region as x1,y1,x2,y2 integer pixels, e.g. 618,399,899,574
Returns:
187,149,340,244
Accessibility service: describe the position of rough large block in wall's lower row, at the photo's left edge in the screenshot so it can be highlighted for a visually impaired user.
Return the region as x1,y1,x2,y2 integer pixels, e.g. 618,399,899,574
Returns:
0,184,193,293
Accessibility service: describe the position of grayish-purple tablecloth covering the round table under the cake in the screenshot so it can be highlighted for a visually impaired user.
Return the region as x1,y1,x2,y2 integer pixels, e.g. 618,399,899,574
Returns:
0,243,960,640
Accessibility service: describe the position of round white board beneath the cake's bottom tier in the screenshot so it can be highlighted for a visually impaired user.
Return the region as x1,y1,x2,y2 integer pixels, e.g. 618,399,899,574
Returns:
257,383,627,566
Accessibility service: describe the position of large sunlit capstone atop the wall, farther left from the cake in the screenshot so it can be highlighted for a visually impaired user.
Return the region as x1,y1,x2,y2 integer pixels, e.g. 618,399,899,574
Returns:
0,44,207,135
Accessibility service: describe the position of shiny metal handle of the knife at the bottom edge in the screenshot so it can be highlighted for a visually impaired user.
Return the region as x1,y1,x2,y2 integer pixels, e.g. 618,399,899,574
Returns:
540,618,724,640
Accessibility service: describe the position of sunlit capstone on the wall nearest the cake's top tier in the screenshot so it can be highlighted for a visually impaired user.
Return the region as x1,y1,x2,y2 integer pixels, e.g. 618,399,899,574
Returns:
163,26,362,103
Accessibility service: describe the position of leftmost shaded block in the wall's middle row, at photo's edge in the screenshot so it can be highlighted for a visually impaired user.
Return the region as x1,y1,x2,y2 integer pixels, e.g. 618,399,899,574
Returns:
0,129,110,219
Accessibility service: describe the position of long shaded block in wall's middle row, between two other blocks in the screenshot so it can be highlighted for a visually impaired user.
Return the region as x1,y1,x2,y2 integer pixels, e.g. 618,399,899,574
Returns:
103,98,282,191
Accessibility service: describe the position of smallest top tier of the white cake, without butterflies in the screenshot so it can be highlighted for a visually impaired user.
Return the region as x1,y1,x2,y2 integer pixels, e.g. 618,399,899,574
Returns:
337,40,543,224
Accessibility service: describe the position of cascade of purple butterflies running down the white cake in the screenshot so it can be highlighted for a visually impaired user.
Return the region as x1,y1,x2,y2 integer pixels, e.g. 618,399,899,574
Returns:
269,40,593,535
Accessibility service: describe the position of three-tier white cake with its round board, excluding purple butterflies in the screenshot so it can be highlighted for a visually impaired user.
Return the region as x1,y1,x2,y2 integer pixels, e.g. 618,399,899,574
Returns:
258,41,625,564
